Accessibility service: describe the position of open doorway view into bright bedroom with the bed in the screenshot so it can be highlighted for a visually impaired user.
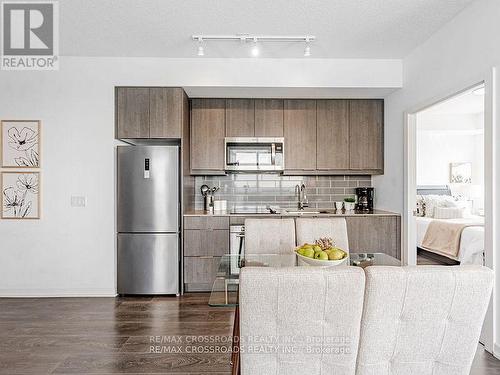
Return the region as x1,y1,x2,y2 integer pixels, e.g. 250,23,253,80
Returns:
414,84,485,266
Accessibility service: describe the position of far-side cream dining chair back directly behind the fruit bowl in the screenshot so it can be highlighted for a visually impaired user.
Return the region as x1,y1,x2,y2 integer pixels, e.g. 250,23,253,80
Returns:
295,217,349,253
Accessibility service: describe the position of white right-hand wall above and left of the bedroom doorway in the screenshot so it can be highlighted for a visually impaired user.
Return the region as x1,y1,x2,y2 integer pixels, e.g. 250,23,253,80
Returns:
373,0,500,355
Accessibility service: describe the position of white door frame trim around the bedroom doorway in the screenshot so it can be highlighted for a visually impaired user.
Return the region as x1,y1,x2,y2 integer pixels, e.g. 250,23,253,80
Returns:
402,72,500,355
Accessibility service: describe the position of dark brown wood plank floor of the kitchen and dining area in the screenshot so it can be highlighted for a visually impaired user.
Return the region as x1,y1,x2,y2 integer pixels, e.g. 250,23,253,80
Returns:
0,293,500,375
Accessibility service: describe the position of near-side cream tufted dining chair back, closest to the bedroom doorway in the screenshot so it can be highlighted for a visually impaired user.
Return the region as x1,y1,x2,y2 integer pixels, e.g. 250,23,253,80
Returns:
356,266,493,375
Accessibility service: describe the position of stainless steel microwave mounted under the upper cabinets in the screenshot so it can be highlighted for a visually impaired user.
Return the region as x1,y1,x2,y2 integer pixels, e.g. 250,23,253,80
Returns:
224,137,285,172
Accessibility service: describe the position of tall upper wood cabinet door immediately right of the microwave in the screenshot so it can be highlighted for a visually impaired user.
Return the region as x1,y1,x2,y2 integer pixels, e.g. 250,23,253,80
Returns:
284,99,316,171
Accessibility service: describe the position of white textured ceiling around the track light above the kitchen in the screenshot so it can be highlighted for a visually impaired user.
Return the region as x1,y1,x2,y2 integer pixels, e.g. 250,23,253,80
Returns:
59,0,473,59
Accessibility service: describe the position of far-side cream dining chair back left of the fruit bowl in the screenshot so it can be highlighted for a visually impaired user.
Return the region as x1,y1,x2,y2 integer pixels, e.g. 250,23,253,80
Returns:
245,219,295,254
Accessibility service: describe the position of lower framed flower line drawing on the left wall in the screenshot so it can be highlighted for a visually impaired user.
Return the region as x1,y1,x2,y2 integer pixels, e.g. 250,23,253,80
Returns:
1,172,40,219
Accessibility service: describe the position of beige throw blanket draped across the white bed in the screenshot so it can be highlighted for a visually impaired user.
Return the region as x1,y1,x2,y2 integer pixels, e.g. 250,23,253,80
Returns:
422,220,478,257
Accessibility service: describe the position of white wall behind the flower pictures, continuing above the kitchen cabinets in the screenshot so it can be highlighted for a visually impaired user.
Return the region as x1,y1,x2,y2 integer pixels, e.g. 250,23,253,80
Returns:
0,57,402,296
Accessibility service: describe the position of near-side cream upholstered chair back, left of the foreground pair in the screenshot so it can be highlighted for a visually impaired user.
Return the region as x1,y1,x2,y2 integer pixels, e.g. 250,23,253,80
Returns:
239,267,365,375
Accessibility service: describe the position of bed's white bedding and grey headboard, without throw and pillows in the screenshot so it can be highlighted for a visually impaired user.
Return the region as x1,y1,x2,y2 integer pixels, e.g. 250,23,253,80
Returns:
415,186,484,265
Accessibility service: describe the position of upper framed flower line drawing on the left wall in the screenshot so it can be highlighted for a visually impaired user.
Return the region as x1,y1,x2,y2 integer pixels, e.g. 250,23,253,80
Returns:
0,120,41,168
